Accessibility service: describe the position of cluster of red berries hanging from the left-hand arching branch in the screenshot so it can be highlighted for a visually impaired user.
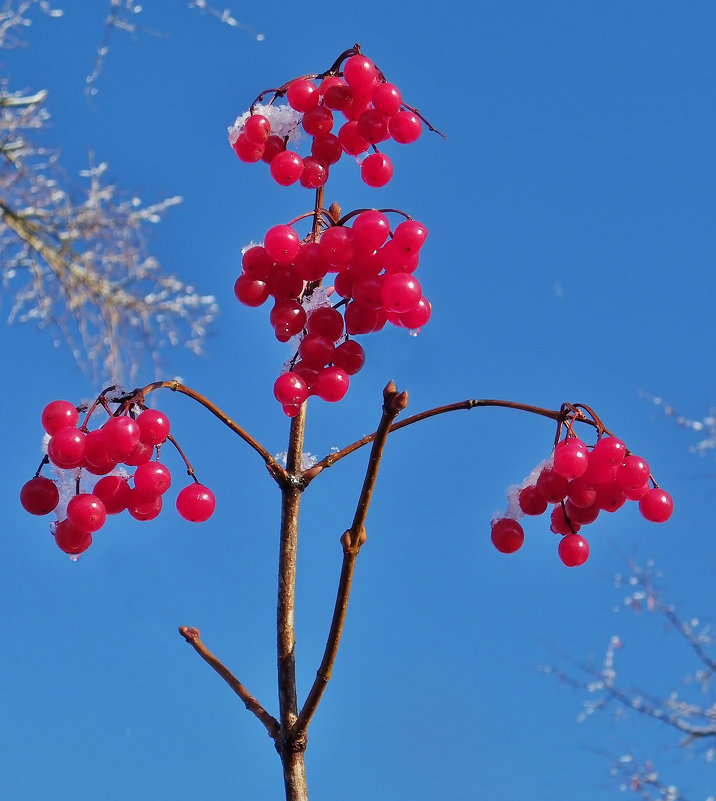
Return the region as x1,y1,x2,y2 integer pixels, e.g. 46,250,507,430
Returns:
20,400,215,555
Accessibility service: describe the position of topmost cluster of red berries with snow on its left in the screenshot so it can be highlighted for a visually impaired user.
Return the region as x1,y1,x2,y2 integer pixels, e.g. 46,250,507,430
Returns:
229,53,422,189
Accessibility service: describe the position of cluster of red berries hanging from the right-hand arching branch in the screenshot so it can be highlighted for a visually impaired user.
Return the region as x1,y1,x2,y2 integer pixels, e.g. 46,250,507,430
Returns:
492,436,674,567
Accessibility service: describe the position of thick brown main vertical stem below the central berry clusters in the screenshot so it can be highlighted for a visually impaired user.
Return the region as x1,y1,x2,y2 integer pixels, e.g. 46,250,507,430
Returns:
276,403,308,801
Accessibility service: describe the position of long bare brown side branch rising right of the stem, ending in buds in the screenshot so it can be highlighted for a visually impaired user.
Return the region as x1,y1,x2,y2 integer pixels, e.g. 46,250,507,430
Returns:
294,381,408,737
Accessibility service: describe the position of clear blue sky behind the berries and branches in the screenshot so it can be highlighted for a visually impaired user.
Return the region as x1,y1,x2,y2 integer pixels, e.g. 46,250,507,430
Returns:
0,0,716,801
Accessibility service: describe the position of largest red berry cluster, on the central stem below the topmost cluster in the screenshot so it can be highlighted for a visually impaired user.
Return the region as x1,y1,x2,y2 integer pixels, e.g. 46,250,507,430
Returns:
234,209,430,416
